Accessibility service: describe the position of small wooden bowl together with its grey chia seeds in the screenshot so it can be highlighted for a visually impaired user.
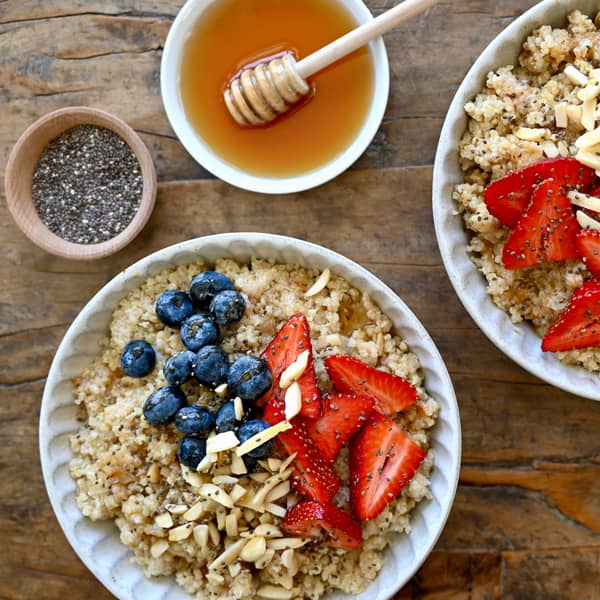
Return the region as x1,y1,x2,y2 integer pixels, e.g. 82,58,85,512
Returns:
5,107,156,260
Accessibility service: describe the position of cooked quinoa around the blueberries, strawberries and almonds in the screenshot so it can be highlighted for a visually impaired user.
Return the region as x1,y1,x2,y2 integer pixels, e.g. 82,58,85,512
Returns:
70,260,439,599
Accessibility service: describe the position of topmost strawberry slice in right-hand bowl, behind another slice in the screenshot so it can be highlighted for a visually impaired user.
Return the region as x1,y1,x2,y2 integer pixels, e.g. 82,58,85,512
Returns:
484,158,595,228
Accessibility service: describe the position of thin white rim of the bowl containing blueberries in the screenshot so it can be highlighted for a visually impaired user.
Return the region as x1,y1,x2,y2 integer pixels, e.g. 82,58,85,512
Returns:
39,232,462,600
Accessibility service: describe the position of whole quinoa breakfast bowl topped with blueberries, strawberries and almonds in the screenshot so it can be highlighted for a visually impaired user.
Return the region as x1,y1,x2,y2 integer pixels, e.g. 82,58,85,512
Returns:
40,234,460,600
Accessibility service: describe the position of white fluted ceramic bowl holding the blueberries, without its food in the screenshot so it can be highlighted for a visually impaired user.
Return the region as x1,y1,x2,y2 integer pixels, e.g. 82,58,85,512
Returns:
40,233,461,600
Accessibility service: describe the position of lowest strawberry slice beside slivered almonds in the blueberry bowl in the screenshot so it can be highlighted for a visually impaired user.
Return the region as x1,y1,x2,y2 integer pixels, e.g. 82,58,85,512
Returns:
282,502,362,550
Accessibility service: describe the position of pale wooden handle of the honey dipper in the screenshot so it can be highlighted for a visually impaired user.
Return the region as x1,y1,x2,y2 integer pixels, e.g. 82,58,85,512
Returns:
296,0,439,79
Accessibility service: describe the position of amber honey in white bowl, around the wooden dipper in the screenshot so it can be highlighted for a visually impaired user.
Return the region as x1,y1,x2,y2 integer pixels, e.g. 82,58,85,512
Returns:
180,0,375,177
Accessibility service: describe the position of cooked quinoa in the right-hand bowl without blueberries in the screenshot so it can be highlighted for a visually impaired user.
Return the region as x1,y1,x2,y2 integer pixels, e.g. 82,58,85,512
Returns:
453,11,600,372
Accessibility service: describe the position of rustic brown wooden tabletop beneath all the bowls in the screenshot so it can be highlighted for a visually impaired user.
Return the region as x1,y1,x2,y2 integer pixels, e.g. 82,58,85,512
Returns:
0,0,600,600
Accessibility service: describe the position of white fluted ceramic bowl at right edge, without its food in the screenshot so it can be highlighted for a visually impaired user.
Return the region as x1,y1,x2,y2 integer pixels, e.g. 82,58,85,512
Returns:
433,0,600,400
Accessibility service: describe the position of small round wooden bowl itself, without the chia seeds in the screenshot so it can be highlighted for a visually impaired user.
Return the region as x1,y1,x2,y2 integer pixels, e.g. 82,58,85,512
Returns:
5,107,156,260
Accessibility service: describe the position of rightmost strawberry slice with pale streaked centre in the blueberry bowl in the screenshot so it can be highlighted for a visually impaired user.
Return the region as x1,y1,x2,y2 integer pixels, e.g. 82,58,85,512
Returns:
350,413,425,521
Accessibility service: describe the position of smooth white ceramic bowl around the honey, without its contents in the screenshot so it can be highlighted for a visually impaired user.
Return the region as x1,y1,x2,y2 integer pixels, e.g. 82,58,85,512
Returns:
160,0,390,194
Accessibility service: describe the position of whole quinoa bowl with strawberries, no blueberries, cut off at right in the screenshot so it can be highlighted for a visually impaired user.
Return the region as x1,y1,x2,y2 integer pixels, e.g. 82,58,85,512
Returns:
433,0,600,400
